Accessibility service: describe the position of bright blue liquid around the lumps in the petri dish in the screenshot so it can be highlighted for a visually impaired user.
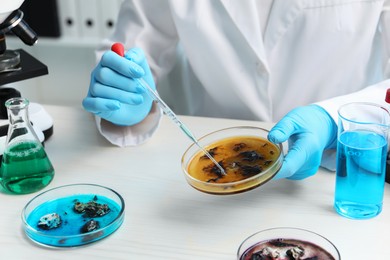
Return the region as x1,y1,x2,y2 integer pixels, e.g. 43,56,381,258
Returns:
26,194,123,247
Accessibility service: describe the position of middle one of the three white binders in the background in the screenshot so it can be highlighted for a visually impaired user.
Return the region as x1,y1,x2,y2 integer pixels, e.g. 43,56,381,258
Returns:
77,0,101,38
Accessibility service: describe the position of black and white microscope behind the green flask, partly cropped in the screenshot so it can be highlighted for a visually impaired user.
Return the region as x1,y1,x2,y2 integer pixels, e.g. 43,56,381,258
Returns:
0,0,53,150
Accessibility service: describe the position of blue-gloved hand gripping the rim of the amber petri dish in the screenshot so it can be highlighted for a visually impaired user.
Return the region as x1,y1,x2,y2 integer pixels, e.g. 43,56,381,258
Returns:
268,105,337,180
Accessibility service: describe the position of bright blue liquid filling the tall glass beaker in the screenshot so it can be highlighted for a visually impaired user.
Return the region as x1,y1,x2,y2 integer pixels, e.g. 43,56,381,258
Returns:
334,131,387,219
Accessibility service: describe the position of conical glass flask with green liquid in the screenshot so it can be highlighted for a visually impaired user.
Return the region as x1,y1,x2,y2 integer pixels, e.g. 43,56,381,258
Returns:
0,97,54,194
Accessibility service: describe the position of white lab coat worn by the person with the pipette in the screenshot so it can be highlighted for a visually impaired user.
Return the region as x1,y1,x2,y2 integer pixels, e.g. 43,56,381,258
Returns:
97,0,390,146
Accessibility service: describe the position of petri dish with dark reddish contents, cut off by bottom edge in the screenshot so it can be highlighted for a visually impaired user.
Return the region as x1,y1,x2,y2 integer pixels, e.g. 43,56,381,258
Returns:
237,227,341,260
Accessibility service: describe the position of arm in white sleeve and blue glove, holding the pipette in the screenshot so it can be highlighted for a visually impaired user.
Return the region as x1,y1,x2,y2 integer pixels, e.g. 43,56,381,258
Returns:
83,0,177,146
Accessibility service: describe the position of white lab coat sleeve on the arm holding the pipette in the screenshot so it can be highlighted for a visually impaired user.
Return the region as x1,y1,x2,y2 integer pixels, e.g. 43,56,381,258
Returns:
91,0,178,147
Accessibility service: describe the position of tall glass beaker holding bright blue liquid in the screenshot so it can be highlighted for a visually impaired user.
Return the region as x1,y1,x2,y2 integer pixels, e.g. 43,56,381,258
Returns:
334,102,390,219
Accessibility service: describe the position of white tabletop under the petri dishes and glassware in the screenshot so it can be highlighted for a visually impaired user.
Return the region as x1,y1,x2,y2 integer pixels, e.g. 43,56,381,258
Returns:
0,106,390,260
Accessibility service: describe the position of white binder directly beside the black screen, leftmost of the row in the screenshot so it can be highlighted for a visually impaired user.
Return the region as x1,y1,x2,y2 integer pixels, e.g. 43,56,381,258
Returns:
57,0,80,38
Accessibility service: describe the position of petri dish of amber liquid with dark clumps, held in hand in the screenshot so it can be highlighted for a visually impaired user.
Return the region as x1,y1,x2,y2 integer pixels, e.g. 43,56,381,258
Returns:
181,126,284,195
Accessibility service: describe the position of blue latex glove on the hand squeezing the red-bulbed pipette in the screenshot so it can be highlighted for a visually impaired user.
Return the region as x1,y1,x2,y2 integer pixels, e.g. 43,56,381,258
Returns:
83,48,156,126
